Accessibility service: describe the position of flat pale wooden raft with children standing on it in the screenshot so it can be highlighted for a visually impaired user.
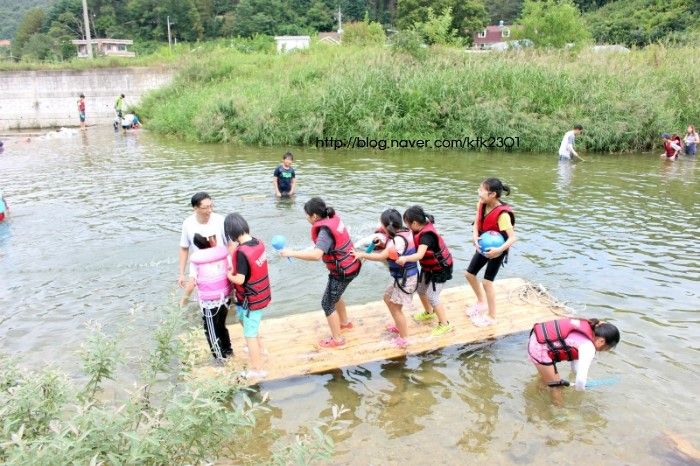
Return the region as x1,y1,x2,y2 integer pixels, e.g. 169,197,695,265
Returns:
192,278,564,383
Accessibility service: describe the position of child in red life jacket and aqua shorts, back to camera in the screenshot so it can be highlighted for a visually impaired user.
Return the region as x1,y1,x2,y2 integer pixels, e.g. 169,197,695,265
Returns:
224,213,272,379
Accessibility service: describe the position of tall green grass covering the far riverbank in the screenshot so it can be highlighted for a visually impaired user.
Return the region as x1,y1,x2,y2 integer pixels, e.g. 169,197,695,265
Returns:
139,45,700,152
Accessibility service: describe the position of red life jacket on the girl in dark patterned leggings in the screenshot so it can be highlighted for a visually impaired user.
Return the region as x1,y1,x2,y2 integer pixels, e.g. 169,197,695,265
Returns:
311,215,362,278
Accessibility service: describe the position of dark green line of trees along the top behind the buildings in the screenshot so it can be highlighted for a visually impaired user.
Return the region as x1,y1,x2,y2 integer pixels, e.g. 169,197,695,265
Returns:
5,0,700,60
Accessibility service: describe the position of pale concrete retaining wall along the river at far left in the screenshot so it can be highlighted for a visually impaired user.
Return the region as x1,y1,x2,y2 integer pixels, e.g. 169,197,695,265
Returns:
0,68,173,130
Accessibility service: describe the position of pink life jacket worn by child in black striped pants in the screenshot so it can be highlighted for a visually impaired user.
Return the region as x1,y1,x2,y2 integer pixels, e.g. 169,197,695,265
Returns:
190,246,231,303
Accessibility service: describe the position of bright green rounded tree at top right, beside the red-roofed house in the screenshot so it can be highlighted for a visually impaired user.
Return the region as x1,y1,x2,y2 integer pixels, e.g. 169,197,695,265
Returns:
518,0,591,48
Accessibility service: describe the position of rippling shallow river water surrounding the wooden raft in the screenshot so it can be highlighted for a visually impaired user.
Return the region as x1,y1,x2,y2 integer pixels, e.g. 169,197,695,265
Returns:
0,129,700,464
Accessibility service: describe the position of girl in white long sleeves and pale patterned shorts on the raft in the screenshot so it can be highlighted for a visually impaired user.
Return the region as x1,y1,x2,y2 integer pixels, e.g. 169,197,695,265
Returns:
353,209,418,348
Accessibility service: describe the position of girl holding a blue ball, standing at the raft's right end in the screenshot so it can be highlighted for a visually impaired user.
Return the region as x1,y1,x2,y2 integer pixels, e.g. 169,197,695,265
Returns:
464,178,516,327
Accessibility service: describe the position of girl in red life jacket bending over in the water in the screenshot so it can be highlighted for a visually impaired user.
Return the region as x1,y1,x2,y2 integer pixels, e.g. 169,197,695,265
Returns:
527,318,620,396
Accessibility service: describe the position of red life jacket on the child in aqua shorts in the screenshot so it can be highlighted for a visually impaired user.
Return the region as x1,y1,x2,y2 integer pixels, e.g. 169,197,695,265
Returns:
231,240,272,311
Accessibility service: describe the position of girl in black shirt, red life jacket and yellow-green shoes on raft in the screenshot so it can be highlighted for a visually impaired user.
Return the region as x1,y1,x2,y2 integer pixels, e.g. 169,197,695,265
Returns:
396,205,454,336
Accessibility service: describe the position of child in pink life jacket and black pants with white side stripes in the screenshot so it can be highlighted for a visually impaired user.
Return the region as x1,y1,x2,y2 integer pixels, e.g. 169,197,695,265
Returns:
190,233,233,361
